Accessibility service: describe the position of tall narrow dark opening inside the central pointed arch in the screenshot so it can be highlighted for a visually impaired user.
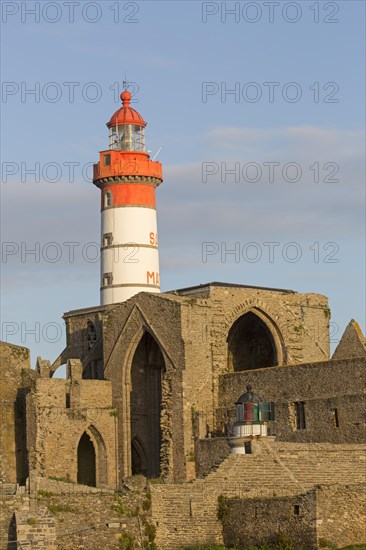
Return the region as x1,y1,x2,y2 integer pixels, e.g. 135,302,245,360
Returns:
130,332,165,477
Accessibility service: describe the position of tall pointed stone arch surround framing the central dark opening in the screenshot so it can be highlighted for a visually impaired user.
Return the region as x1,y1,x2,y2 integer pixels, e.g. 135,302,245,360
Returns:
105,306,180,480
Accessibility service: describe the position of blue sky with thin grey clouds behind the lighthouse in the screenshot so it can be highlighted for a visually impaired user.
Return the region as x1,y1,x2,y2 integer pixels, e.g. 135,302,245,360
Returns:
1,0,365,363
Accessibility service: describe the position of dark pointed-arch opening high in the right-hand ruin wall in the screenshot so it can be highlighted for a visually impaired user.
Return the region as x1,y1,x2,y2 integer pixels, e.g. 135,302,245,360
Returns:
227,312,277,372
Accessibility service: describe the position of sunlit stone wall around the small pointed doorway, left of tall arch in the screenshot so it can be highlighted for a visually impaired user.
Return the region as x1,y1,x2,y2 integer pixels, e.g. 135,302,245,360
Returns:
27,378,117,486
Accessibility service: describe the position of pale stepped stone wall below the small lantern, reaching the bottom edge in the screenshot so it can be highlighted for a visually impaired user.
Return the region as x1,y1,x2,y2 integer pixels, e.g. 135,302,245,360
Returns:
152,439,366,550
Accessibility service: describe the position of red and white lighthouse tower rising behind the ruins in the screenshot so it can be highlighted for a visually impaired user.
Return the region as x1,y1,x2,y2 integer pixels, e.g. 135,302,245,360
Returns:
93,90,163,305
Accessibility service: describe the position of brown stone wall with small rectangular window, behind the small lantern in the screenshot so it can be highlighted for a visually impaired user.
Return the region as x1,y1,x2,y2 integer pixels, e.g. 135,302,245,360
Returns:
218,359,366,443
